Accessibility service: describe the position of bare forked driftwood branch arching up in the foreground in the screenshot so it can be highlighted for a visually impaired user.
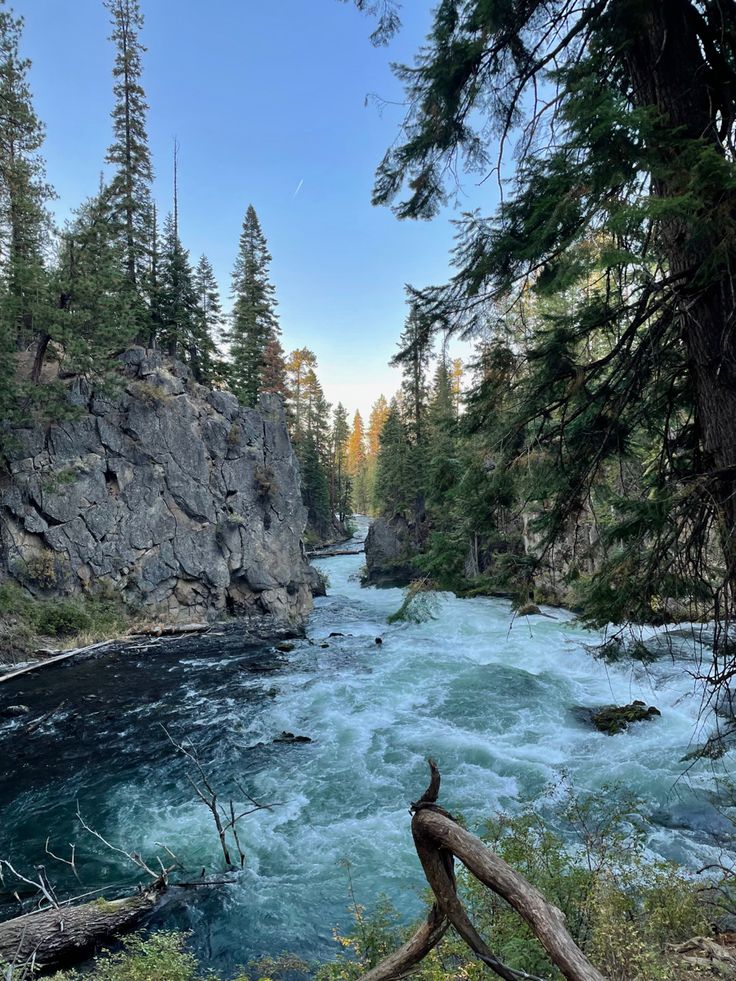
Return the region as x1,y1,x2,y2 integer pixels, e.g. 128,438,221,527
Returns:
363,760,605,981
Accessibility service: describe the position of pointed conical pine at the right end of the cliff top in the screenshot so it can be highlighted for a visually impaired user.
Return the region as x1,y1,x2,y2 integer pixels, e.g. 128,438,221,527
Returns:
227,205,279,406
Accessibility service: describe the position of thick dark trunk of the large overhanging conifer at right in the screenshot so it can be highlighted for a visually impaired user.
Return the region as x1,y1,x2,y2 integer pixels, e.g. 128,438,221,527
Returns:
614,0,736,603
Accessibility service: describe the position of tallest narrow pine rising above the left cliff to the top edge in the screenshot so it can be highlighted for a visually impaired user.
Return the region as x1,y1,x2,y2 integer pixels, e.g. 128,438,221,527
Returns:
105,0,153,341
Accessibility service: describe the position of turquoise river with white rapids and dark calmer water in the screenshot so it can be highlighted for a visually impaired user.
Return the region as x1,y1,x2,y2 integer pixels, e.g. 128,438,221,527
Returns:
0,524,731,971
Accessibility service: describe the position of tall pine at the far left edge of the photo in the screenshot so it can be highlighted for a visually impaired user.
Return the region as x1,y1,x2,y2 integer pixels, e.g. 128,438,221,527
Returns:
0,2,53,384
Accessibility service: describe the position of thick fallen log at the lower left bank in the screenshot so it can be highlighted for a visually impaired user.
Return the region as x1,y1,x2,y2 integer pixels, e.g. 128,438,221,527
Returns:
0,882,166,968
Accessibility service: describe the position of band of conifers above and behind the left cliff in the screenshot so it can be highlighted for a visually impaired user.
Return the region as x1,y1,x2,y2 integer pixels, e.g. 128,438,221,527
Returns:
0,0,394,542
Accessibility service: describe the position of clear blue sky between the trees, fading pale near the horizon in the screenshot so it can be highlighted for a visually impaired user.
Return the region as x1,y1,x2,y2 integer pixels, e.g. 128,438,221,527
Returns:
7,0,493,414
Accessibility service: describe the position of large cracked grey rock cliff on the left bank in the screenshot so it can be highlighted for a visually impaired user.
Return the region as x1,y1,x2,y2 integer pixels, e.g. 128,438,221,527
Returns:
0,348,312,622
